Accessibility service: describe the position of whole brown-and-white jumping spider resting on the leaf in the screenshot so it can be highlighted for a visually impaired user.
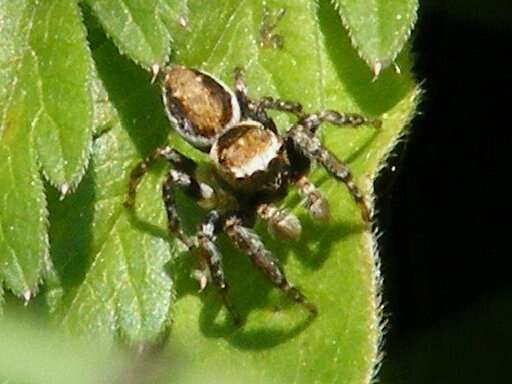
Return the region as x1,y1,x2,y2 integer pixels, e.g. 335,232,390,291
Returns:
125,65,380,321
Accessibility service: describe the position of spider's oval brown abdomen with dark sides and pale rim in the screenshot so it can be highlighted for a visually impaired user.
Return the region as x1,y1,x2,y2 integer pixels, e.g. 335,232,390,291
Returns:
162,66,240,150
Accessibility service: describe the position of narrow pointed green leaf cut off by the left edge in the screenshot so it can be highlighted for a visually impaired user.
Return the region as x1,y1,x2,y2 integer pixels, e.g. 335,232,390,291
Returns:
0,106,48,300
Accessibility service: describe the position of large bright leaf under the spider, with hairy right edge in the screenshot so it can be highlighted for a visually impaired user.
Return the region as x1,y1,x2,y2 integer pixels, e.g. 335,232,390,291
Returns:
158,0,418,383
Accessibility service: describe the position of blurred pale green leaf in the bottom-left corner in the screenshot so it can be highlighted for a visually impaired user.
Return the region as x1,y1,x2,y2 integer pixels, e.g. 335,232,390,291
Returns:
0,313,126,384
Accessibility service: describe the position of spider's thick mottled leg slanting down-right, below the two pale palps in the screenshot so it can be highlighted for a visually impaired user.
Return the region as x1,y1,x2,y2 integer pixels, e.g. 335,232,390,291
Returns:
224,214,317,314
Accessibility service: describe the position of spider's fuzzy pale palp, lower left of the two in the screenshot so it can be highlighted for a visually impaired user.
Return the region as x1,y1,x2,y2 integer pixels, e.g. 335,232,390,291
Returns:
256,203,302,240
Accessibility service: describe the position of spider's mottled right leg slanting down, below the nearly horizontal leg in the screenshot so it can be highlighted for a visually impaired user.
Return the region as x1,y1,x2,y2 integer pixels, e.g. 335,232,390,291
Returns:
286,123,371,222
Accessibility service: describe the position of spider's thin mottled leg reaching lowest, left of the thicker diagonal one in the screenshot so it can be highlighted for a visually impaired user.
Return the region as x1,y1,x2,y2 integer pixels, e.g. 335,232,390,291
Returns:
197,211,240,324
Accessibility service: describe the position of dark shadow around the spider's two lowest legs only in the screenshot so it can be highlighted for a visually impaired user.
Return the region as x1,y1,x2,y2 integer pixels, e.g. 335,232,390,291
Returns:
171,236,314,350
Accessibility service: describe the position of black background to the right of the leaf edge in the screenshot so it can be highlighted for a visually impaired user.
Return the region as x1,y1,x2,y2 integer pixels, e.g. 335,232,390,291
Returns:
376,0,512,384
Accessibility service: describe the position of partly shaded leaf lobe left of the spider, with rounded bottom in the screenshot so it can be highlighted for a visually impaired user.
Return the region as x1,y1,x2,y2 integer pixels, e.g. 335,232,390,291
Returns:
50,41,173,343
